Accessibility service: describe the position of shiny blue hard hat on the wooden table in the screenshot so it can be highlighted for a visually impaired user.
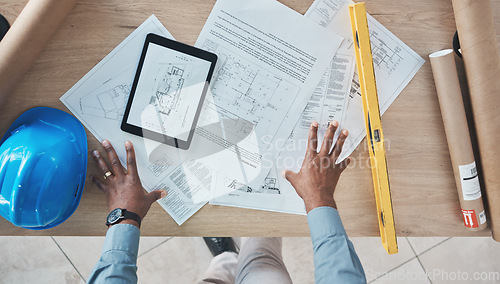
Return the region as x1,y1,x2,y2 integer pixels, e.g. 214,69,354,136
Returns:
0,107,87,230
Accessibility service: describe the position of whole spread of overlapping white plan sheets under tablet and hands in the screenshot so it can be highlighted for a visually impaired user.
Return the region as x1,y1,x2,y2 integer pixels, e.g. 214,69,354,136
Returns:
61,0,424,225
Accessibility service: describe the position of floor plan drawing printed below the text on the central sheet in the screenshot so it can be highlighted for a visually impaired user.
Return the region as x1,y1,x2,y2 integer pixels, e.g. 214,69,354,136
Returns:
202,40,300,150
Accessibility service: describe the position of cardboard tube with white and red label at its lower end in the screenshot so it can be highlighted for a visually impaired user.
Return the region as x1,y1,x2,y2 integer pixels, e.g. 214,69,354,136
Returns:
429,49,487,231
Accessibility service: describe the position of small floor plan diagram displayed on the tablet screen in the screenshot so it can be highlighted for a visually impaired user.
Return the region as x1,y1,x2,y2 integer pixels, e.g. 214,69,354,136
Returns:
150,64,186,115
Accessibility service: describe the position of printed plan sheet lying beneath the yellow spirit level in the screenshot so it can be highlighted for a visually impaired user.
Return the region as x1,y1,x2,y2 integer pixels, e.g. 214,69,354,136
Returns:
212,0,424,214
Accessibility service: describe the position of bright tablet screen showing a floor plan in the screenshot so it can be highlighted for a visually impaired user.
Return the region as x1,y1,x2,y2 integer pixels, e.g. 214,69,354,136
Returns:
126,38,213,141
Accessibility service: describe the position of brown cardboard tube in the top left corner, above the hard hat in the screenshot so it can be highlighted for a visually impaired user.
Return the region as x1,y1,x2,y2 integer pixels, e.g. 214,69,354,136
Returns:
0,0,76,105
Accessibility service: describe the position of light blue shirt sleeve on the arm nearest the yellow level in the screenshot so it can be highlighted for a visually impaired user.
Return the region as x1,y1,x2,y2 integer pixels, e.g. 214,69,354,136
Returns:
307,207,366,283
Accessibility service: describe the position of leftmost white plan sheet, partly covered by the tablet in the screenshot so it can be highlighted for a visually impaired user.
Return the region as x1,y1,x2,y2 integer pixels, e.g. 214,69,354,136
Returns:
61,15,215,225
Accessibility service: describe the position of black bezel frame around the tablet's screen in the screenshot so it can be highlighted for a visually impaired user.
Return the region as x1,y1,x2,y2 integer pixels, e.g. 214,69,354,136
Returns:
121,33,217,150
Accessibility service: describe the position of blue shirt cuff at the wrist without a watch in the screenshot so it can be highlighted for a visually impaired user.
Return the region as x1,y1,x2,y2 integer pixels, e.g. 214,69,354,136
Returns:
307,206,347,242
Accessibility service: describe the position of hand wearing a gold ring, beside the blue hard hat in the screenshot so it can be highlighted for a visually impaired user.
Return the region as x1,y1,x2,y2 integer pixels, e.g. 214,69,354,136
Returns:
91,140,167,227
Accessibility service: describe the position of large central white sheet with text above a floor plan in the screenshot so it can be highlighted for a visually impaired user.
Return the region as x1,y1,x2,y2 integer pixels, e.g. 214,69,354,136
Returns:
174,0,343,201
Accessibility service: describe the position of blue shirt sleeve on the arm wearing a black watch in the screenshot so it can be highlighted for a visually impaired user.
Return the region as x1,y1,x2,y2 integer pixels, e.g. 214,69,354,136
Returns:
87,224,140,283
